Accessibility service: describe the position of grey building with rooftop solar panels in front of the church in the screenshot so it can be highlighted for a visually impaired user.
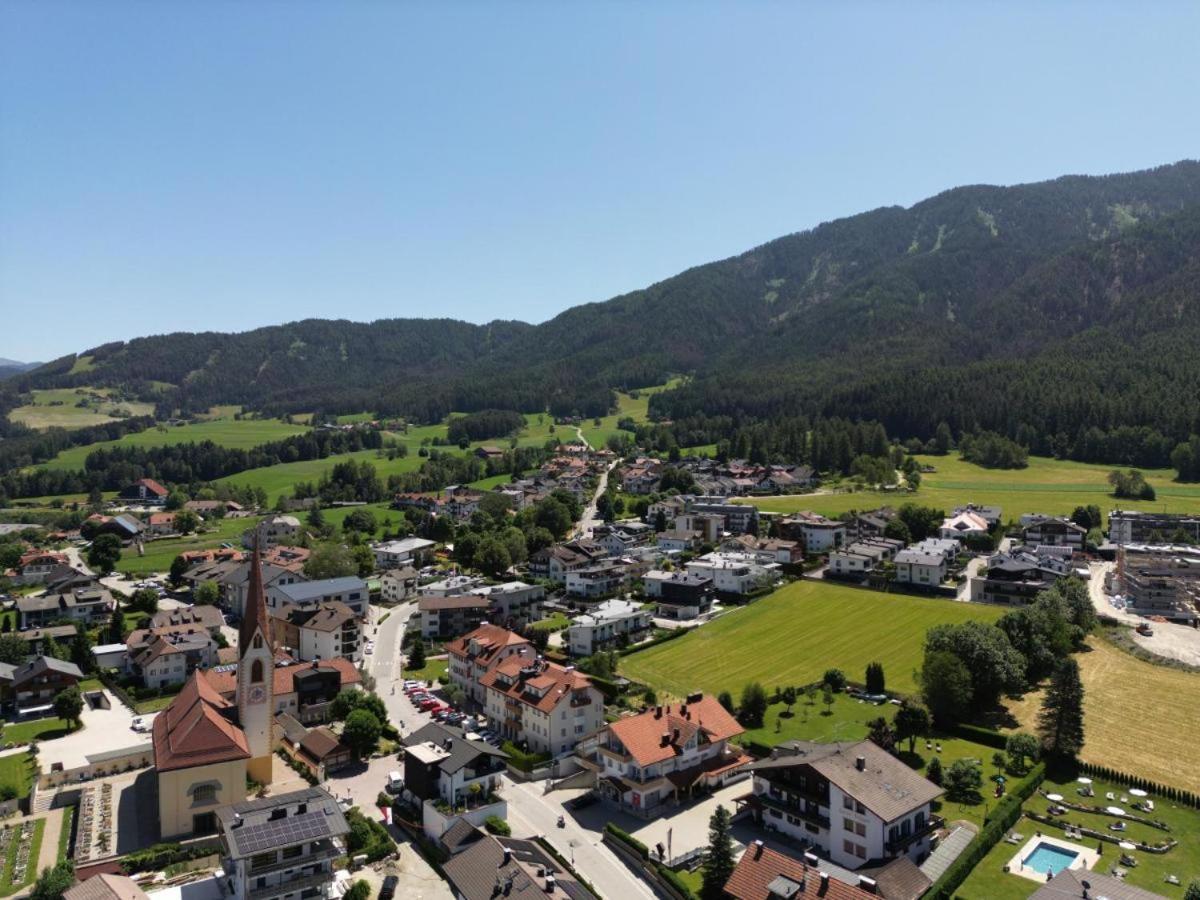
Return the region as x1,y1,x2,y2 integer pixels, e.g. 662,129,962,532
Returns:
217,787,350,900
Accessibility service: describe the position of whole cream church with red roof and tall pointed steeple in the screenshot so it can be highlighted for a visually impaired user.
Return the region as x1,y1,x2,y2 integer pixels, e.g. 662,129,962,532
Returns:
154,547,275,840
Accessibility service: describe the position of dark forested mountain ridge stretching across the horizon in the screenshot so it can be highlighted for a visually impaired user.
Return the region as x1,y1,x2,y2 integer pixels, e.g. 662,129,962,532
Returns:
6,162,1200,452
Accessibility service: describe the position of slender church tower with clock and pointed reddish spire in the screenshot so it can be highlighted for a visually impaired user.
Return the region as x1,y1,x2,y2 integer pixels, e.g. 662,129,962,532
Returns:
238,538,275,785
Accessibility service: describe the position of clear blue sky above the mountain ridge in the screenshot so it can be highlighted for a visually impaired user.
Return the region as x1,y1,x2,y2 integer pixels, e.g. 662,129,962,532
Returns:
0,0,1200,359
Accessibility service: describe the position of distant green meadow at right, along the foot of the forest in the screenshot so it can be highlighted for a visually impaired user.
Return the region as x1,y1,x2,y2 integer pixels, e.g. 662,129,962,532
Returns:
746,454,1200,520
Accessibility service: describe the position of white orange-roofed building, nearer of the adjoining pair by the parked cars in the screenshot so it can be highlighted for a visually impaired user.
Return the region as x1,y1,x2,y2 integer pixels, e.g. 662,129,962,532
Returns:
480,646,604,757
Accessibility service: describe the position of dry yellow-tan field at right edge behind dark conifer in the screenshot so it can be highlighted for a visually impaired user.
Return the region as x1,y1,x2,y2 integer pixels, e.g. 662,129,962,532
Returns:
1009,636,1200,792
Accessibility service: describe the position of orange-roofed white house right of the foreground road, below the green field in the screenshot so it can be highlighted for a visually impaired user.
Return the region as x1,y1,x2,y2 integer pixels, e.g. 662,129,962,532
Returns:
581,694,751,815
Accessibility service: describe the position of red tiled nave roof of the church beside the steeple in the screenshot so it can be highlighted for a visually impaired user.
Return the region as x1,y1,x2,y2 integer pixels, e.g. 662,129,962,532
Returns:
154,671,250,772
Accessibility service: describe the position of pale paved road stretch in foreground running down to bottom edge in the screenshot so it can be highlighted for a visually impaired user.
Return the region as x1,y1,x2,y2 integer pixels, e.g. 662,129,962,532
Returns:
504,776,655,900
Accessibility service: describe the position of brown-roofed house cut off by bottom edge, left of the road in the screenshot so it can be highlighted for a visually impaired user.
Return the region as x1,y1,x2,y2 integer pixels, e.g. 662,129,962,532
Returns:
442,833,596,900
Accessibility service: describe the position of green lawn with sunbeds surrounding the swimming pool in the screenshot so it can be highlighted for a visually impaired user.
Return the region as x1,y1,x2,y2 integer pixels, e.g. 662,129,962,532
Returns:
955,766,1200,900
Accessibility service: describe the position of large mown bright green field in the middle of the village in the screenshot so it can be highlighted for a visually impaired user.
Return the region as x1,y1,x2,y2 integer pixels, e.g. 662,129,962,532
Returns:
620,581,1004,696
